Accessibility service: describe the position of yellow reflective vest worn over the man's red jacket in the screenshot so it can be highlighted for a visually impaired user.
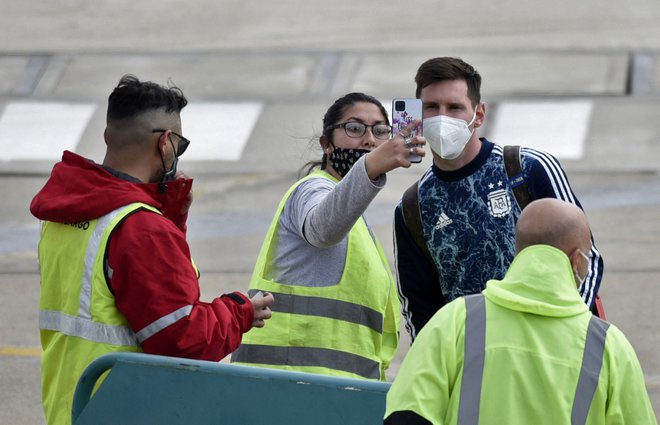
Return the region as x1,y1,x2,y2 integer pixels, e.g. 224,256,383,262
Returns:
39,203,160,425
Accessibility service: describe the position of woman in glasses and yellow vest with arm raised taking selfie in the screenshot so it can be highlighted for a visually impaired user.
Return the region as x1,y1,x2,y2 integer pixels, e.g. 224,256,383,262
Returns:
232,93,425,380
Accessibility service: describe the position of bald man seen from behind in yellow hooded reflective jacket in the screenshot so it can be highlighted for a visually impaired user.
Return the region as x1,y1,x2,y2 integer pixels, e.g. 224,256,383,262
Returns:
384,198,657,425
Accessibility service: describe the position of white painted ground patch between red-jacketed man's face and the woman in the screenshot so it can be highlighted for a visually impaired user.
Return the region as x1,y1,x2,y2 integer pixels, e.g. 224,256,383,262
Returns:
181,102,263,161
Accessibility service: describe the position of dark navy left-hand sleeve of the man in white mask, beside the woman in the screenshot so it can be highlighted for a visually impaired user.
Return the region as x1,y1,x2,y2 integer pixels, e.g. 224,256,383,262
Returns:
394,203,445,340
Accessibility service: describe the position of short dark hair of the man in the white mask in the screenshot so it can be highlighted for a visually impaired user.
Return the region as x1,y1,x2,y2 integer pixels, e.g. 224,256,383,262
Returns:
415,57,481,106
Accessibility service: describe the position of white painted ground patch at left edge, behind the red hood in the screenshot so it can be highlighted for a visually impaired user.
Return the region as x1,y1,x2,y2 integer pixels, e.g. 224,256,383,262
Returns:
0,102,96,162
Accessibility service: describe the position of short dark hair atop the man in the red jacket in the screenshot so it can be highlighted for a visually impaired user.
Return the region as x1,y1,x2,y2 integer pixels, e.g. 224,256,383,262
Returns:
106,74,188,122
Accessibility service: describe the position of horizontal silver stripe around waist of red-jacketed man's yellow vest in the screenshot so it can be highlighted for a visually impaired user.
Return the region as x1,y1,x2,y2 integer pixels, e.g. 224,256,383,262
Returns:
39,310,138,347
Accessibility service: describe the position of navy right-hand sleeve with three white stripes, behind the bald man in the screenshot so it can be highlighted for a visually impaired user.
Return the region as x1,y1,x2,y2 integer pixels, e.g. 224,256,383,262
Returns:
521,148,604,309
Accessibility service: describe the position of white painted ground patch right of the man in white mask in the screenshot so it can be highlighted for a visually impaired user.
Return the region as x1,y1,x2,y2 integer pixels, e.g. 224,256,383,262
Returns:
490,101,593,159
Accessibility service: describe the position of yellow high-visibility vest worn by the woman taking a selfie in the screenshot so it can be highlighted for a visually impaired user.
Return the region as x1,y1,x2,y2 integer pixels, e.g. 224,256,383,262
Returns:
232,170,400,380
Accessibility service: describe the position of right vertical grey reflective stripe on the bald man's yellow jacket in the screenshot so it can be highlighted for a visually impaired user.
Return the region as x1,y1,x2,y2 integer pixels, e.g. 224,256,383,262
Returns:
571,316,610,425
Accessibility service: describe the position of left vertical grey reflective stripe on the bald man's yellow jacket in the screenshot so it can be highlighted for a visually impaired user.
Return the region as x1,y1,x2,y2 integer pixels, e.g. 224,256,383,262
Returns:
457,294,486,425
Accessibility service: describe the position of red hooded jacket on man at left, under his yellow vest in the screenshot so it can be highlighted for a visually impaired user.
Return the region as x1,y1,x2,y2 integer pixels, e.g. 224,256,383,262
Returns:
30,151,254,361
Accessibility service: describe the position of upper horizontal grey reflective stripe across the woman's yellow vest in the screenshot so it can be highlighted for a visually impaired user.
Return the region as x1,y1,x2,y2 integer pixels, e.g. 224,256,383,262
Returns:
248,289,383,334
